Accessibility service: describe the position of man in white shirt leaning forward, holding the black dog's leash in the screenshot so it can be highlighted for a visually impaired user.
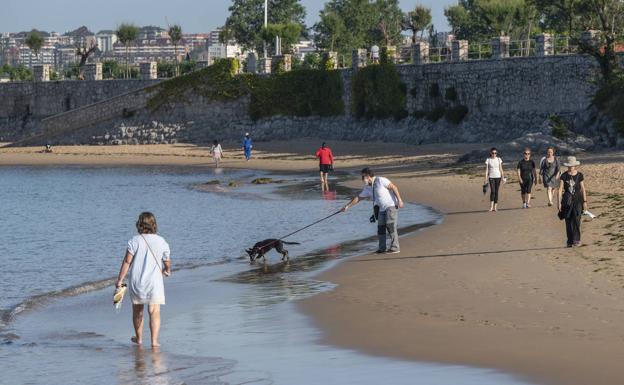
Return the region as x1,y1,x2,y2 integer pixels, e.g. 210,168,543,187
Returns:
342,167,403,254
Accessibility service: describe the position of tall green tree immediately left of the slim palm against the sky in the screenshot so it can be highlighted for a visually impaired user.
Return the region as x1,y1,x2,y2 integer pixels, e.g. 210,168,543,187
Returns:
370,0,403,47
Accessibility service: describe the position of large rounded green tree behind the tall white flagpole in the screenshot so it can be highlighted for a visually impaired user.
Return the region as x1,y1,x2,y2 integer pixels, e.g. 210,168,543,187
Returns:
221,0,306,52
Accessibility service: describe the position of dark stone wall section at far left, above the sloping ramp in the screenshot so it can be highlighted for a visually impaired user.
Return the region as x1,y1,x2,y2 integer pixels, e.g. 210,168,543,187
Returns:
0,80,158,141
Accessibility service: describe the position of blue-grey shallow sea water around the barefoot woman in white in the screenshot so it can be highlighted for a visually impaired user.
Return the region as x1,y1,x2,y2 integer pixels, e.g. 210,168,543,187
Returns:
0,168,526,385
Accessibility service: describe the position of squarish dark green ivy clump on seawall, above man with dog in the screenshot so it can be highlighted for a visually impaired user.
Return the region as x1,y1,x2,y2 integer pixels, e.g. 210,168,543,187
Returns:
351,64,408,120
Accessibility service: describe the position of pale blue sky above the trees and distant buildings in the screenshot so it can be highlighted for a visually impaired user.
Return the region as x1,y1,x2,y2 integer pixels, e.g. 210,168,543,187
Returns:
0,0,457,33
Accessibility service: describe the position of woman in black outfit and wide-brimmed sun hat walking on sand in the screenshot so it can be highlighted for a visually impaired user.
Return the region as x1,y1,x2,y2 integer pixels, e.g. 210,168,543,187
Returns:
557,156,588,247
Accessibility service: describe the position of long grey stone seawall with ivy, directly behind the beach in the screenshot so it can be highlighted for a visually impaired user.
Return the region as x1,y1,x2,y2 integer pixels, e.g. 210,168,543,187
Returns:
3,55,611,148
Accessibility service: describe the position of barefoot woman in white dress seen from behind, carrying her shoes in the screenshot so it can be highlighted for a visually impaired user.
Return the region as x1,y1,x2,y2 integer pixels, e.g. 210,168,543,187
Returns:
115,212,171,347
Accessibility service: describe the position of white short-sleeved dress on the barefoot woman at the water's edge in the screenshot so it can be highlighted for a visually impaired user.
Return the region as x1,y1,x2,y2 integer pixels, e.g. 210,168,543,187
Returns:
128,234,170,305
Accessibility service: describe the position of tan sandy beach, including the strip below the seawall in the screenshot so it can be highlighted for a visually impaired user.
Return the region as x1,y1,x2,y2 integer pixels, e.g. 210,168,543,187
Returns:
0,139,624,385
